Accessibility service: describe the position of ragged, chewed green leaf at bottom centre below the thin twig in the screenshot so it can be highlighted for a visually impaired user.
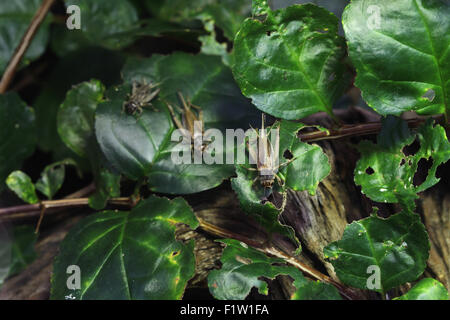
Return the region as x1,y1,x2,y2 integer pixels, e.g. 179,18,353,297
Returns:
208,239,341,300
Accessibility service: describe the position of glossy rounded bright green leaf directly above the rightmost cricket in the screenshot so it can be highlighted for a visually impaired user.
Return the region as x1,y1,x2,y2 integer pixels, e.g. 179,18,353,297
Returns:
232,4,348,119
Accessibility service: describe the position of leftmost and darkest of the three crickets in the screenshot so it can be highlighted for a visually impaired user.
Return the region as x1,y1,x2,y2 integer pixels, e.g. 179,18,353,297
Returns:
123,81,160,115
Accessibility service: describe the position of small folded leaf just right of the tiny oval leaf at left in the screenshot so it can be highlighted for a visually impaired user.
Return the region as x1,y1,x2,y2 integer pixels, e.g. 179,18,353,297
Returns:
36,159,76,199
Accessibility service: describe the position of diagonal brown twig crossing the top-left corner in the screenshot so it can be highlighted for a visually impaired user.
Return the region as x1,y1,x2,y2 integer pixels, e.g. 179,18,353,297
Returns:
0,0,55,94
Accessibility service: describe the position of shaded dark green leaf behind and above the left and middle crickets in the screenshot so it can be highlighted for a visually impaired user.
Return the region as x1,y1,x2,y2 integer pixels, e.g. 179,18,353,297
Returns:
122,52,260,130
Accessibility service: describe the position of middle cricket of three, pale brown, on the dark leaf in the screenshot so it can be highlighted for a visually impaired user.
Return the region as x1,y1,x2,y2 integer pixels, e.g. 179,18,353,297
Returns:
166,92,205,151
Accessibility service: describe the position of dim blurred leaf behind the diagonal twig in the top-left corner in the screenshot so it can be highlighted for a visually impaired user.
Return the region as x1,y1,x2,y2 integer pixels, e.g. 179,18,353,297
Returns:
0,0,50,74
